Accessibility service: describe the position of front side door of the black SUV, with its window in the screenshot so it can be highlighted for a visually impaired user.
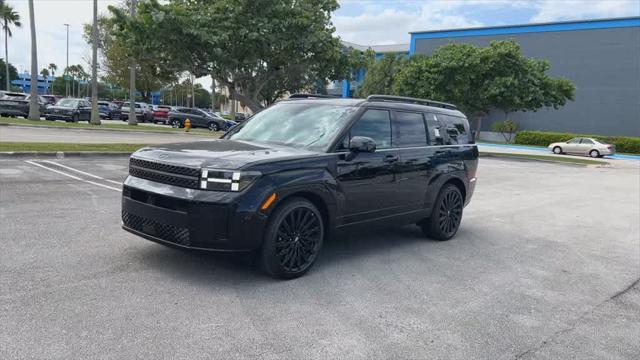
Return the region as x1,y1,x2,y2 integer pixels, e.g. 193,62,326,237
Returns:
336,109,402,224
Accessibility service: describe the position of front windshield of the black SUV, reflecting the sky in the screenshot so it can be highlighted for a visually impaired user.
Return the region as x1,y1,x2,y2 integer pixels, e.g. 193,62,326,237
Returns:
228,102,356,150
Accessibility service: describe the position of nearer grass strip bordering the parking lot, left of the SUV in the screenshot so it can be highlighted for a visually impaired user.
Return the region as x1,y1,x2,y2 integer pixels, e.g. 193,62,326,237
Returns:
0,141,148,152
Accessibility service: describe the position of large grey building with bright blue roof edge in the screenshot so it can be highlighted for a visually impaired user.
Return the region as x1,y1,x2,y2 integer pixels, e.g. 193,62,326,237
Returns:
409,17,640,136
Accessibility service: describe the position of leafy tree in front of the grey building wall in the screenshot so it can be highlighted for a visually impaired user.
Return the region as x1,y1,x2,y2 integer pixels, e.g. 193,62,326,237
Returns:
394,41,575,136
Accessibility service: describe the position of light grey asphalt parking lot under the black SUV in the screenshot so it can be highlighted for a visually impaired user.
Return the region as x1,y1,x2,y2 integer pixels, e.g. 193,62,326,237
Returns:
0,157,640,359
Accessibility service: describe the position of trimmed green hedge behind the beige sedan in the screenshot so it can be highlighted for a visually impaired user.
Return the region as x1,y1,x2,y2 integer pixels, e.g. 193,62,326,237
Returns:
514,131,640,154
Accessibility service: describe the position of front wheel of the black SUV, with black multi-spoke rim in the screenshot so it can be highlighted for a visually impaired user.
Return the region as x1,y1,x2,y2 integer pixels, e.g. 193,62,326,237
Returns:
260,198,324,279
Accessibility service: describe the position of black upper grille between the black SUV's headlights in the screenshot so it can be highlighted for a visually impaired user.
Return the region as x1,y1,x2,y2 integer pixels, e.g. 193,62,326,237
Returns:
129,158,200,189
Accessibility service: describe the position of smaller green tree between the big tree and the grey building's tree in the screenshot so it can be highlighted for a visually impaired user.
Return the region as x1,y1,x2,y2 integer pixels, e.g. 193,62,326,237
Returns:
357,53,408,97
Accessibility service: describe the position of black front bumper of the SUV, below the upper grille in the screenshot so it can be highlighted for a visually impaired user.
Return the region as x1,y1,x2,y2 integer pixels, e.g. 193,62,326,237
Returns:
122,176,267,251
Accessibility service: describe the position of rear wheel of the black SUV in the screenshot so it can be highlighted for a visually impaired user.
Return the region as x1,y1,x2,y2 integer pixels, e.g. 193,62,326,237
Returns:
421,184,464,241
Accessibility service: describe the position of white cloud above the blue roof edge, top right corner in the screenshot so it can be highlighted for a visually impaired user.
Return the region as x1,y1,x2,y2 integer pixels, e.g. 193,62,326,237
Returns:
531,0,640,22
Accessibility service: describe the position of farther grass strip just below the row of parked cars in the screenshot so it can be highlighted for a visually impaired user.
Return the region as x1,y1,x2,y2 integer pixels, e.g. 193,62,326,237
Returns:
0,117,215,137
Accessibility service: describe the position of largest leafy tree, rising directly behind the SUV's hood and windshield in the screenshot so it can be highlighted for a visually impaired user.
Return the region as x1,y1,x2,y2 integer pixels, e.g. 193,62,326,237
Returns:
110,0,349,111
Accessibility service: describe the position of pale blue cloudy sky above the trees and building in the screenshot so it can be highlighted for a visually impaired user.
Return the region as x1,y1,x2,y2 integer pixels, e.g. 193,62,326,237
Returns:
1,0,640,88
